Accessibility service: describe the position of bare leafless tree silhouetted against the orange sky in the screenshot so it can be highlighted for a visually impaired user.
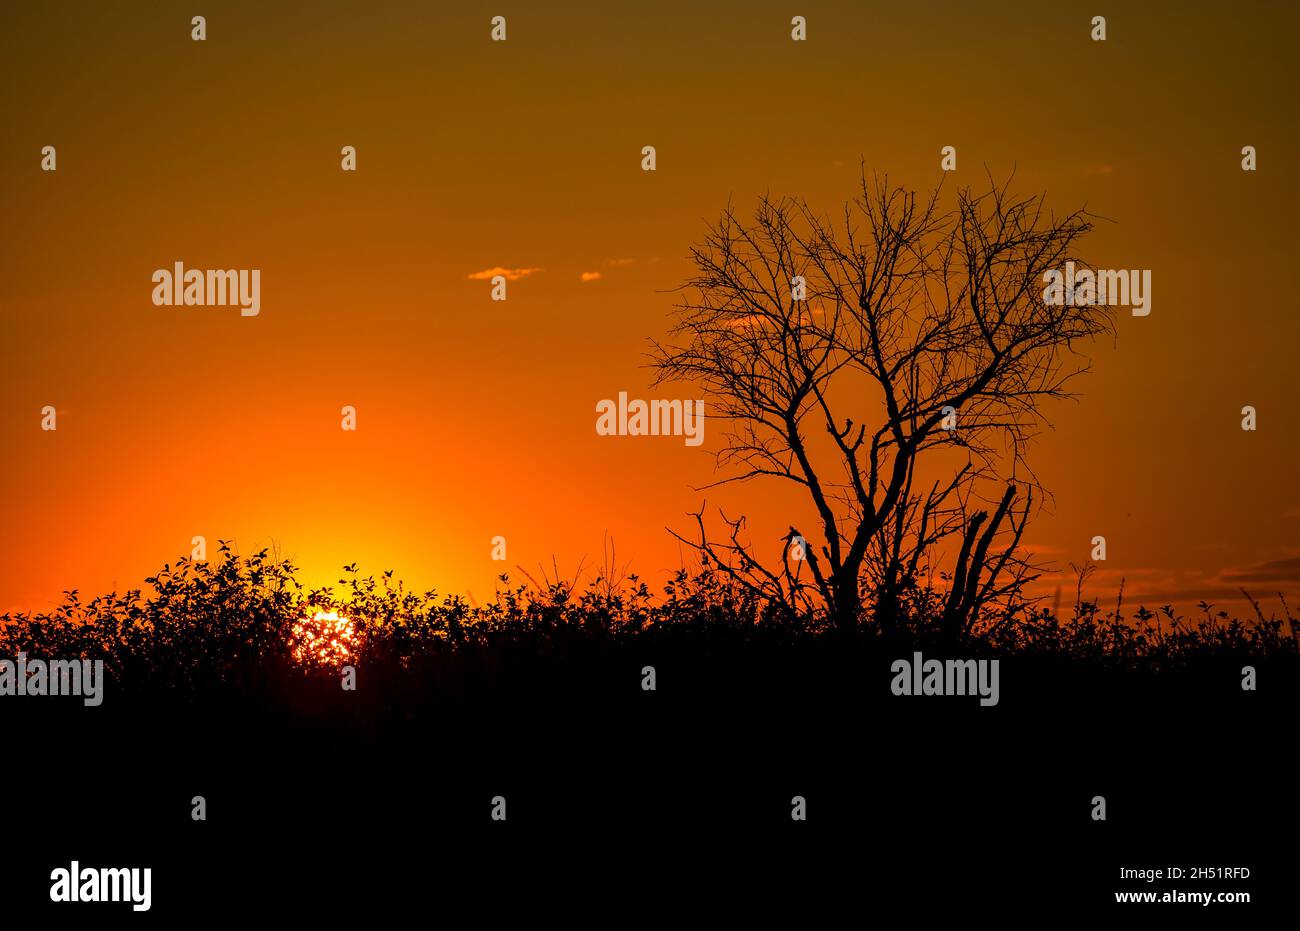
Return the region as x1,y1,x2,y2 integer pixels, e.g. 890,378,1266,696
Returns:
654,176,1113,638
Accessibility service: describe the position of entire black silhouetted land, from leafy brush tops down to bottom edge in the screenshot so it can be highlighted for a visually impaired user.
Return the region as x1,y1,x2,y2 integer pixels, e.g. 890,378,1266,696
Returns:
0,544,1300,922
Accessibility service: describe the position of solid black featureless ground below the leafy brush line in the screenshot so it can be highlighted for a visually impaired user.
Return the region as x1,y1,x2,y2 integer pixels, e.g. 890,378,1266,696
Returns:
0,641,1300,927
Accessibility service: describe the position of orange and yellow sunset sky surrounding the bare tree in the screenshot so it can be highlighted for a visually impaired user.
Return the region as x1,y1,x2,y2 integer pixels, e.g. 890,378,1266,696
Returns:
0,3,1300,611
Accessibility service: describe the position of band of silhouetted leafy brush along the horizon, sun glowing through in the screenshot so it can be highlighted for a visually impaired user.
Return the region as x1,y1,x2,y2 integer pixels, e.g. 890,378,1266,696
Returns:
0,541,1297,700
